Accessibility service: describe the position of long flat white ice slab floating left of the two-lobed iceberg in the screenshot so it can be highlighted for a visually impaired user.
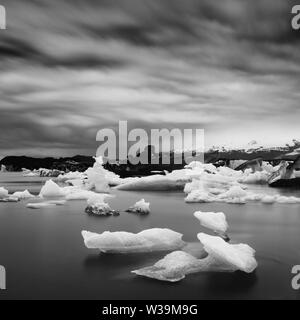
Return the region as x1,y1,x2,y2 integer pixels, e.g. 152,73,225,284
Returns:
82,228,185,253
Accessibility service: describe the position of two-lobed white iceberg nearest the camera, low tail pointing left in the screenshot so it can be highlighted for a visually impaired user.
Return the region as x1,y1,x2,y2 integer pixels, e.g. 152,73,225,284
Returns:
132,233,257,282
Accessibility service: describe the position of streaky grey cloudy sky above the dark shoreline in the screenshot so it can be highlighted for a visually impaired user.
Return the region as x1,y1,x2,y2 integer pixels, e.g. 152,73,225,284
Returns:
0,0,300,157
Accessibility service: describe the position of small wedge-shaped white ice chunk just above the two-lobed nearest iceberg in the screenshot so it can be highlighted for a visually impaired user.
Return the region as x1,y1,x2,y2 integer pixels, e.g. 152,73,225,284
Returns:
194,211,228,234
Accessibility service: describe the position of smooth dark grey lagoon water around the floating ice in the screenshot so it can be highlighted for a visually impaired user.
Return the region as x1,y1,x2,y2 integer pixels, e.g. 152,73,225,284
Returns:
0,173,300,300
